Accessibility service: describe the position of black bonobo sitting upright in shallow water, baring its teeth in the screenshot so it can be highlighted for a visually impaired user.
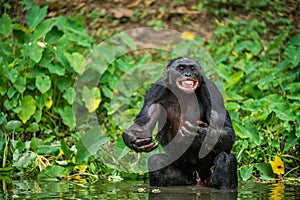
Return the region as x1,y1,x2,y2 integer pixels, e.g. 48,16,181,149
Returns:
122,58,238,189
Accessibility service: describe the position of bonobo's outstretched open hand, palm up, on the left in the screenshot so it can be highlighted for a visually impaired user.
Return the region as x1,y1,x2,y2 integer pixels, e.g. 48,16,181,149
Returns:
122,129,158,152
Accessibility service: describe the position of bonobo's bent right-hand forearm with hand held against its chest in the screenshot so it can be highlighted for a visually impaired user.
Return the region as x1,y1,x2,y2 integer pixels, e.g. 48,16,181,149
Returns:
182,111,235,153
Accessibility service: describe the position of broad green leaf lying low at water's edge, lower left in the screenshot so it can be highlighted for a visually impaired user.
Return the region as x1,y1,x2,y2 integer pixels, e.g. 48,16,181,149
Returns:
38,165,70,180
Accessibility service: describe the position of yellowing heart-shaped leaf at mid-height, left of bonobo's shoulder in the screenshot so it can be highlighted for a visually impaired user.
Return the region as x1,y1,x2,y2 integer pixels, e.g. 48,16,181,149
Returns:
82,86,101,113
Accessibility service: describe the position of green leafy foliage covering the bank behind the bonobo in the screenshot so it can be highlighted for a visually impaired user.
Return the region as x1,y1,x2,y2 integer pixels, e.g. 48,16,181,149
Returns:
0,0,300,184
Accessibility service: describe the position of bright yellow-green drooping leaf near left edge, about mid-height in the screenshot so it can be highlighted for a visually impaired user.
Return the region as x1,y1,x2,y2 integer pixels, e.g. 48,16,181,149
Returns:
18,95,36,124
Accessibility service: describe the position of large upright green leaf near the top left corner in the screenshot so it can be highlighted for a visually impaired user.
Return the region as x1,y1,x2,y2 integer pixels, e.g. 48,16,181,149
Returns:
26,5,48,30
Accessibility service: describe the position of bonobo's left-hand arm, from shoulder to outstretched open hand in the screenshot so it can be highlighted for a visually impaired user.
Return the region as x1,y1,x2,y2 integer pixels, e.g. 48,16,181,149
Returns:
122,84,165,152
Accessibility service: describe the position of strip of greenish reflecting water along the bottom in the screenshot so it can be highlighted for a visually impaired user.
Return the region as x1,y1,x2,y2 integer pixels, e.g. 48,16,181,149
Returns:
0,180,300,200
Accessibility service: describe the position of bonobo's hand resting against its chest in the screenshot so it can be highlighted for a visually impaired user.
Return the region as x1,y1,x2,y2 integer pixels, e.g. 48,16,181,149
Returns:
178,121,208,137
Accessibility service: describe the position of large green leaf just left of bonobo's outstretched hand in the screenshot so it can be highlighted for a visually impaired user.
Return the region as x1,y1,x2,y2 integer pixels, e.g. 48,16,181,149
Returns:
75,126,109,163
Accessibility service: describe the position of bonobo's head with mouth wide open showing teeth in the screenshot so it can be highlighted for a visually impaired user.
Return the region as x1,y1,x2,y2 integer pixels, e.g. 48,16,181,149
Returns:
165,58,202,94
